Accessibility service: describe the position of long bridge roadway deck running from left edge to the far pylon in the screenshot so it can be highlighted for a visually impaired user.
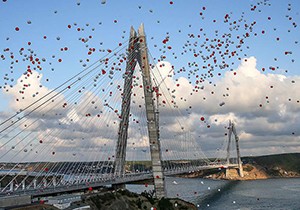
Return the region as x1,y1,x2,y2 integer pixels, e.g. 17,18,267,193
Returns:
0,164,238,198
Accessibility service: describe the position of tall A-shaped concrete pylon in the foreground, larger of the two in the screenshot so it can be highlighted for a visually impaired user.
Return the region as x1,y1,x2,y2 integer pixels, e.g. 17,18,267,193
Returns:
114,24,165,198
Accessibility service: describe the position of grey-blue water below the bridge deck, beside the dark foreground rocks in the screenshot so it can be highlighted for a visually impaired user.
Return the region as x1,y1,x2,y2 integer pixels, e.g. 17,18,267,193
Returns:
127,177,300,210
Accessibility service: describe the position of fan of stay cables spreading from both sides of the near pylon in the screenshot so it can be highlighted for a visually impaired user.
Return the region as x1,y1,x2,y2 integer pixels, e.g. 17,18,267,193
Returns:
0,33,236,195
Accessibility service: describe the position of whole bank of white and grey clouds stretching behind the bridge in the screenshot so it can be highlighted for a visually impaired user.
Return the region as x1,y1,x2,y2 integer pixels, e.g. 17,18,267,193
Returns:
0,57,300,162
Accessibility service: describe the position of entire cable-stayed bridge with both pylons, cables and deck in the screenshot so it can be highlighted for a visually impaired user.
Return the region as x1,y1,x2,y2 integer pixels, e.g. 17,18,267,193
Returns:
0,25,243,202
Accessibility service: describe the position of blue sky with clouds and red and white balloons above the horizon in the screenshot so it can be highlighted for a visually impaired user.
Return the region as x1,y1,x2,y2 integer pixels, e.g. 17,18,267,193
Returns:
0,0,300,161
